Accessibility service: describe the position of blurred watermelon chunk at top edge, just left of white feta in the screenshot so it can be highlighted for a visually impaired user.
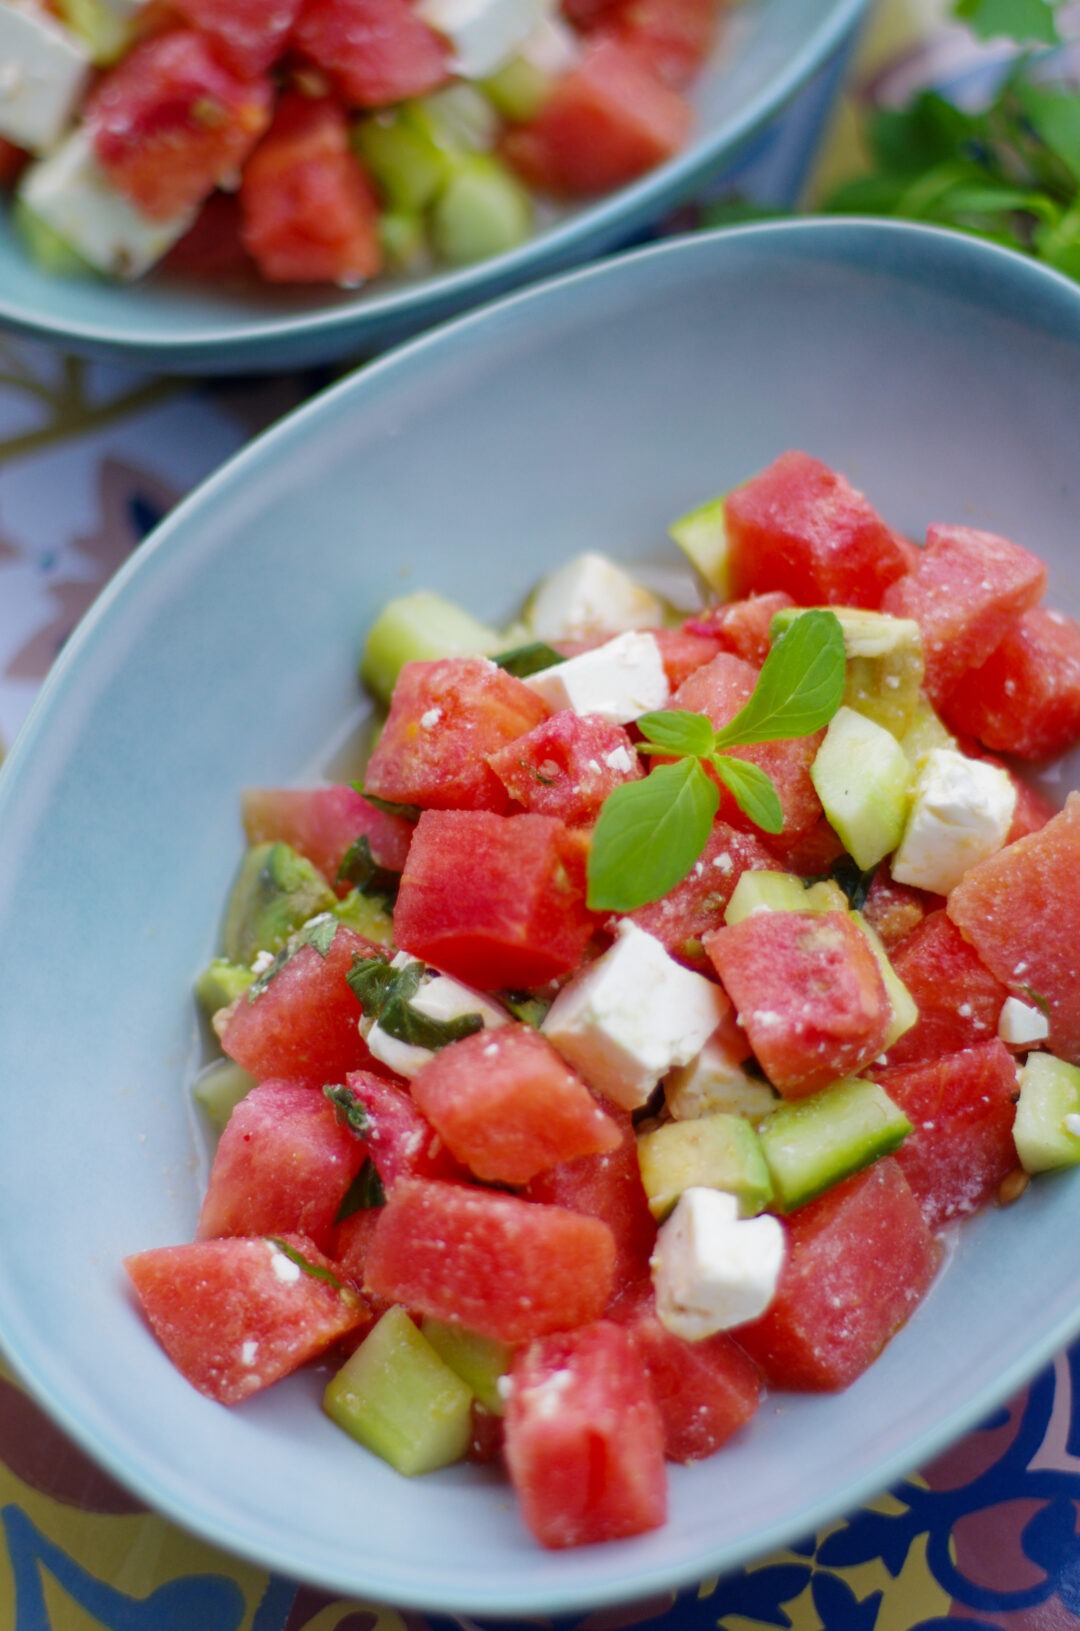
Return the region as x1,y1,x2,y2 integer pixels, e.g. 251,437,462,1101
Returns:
292,0,450,108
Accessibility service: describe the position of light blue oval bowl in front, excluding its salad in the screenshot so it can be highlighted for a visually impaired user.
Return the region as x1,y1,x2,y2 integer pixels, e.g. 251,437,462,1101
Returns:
0,222,1080,1615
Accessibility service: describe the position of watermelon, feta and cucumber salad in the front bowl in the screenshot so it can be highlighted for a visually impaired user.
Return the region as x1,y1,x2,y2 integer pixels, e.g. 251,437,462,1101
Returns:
126,452,1080,1548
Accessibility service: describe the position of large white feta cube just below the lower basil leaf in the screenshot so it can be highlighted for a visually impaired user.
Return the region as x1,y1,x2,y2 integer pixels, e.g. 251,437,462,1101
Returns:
540,918,728,1111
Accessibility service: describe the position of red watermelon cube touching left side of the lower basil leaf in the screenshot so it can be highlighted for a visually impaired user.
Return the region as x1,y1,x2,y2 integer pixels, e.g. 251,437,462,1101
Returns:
393,811,594,992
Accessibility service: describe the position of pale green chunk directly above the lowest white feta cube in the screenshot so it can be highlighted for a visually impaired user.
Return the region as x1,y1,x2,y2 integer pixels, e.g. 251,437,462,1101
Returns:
638,1112,772,1223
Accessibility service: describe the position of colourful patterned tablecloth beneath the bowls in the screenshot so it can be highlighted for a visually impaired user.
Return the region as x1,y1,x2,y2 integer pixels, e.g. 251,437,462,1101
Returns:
0,0,1080,1631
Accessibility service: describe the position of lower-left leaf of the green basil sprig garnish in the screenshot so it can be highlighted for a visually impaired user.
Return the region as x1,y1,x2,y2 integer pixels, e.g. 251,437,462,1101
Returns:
587,758,719,912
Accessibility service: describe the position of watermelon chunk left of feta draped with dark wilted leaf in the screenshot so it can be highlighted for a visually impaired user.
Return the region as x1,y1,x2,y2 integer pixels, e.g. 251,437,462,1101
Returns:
219,925,378,1088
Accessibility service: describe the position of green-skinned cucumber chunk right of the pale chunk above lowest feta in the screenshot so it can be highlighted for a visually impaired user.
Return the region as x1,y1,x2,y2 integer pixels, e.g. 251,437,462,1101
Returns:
759,1076,912,1212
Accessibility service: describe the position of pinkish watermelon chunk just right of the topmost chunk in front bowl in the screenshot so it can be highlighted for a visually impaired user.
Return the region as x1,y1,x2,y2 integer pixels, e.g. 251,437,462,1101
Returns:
881,525,1046,708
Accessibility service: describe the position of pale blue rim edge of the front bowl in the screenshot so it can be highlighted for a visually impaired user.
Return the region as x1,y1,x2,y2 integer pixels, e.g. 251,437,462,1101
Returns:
0,217,1080,1618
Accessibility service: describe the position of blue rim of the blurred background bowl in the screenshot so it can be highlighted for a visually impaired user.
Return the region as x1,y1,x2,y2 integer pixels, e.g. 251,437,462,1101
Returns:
0,0,871,373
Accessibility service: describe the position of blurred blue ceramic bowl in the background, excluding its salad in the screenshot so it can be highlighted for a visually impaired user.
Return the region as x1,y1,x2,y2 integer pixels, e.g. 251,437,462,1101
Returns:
0,0,866,373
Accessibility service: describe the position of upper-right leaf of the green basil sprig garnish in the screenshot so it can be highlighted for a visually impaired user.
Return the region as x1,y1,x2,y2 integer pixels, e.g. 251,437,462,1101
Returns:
715,607,847,746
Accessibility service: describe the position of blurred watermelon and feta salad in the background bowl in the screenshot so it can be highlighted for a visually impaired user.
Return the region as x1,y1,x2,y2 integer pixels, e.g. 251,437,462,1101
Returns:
0,0,724,289
